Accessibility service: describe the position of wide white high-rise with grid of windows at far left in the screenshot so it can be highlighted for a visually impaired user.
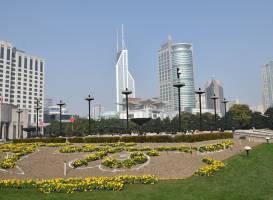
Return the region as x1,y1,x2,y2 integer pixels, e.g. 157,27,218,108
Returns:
0,41,45,128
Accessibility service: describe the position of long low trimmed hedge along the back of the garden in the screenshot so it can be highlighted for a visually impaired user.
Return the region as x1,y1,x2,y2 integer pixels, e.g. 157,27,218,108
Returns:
14,132,233,143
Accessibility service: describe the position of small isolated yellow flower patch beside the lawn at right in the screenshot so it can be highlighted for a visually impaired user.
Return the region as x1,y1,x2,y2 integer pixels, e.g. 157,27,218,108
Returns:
195,157,225,176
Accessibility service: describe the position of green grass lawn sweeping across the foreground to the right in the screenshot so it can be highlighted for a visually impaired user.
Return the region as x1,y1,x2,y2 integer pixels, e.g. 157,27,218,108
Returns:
0,144,273,200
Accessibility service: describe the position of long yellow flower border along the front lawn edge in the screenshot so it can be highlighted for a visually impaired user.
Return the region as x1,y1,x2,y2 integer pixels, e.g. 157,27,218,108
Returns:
0,175,158,193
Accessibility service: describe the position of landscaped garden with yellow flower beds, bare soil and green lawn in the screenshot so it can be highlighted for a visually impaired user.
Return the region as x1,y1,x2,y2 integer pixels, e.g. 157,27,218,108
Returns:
0,135,273,199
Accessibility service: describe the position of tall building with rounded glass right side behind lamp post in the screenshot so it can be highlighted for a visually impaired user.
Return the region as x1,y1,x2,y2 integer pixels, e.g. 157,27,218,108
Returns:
158,38,195,116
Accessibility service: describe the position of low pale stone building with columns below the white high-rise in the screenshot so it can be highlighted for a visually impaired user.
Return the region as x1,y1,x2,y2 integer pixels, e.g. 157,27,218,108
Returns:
0,103,29,142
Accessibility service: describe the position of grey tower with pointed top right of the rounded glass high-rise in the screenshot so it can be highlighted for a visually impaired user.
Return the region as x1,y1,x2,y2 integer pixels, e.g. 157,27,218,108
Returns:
205,79,225,116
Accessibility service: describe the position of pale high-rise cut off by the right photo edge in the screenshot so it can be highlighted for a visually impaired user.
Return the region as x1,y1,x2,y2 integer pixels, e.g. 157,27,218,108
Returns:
262,61,273,111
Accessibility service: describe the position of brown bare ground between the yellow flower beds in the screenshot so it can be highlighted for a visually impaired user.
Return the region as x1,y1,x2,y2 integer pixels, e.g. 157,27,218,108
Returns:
0,140,258,179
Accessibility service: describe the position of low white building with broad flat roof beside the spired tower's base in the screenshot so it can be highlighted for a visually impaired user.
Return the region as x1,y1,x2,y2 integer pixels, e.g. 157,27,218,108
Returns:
120,98,167,119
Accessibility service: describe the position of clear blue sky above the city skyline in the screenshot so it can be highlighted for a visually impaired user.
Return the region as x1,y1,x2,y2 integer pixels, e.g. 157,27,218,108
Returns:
0,0,273,115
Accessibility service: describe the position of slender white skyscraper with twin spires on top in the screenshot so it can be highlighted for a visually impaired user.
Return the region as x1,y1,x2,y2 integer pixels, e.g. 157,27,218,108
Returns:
116,26,135,113
